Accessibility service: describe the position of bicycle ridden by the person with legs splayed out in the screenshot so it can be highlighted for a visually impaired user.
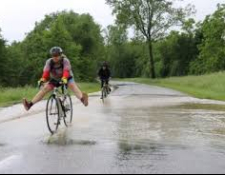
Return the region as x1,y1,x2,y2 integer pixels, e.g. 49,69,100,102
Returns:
46,85,73,134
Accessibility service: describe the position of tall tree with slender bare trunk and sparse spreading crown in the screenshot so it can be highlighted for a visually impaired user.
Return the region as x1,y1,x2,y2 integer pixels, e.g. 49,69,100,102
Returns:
106,0,192,78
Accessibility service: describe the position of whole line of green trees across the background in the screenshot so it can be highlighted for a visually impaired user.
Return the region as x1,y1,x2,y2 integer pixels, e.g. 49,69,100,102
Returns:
0,0,225,87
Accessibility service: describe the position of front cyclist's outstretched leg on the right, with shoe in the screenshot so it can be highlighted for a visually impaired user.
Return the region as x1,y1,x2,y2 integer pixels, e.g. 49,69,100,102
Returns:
68,79,88,106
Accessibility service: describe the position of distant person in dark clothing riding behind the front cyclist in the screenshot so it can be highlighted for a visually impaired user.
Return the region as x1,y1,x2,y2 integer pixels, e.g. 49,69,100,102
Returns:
98,62,111,92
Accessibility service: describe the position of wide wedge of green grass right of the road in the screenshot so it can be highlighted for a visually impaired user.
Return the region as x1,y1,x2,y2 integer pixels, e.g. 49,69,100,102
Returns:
120,72,225,101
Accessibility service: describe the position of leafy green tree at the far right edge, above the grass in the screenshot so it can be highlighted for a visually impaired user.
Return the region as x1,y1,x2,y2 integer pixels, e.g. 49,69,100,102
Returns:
191,4,225,74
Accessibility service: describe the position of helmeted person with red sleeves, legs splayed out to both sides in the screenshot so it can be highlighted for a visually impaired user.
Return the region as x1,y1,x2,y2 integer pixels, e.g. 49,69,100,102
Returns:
23,47,88,111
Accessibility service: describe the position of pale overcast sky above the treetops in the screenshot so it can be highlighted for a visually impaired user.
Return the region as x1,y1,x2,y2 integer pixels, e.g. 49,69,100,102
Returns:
0,0,225,42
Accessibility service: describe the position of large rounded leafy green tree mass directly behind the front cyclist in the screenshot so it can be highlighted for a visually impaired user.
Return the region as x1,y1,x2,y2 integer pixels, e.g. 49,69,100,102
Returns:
14,11,104,85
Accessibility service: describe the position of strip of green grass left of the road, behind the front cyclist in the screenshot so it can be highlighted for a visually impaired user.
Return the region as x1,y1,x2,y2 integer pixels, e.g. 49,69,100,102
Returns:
0,83,100,107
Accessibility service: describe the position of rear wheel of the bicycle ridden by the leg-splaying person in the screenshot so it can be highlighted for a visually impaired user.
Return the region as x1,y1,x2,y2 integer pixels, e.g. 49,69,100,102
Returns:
62,95,73,127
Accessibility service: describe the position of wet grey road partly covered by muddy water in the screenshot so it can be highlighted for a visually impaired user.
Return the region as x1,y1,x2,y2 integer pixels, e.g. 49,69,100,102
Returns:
0,83,225,174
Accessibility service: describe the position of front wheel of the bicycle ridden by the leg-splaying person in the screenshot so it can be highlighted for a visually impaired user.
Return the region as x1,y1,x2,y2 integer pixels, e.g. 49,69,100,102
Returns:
46,95,60,134
